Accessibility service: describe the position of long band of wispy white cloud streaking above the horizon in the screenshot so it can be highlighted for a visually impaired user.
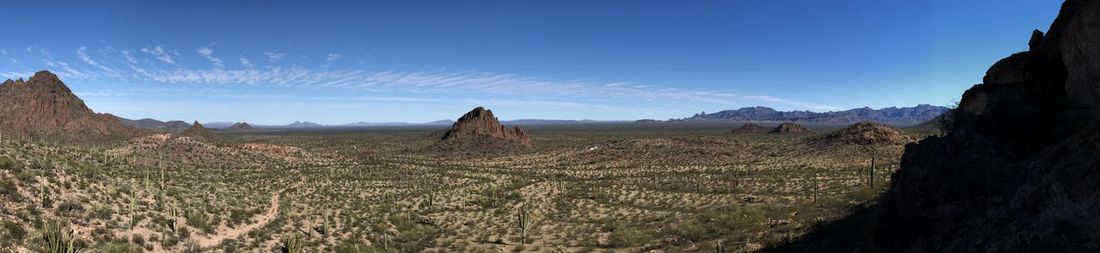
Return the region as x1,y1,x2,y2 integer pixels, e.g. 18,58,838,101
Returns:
19,44,839,110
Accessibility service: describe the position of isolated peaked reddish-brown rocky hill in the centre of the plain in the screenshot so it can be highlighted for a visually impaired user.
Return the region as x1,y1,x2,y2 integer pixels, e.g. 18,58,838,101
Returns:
432,107,532,152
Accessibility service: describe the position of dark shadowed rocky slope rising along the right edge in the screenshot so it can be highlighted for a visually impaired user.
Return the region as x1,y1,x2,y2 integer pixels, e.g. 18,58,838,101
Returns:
776,0,1100,252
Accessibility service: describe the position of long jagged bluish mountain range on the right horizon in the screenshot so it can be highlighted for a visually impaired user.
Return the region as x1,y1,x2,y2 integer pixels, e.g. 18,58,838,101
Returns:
670,105,947,127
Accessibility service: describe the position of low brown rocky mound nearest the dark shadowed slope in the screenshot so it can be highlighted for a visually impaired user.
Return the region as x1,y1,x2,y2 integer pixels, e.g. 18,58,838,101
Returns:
815,122,912,145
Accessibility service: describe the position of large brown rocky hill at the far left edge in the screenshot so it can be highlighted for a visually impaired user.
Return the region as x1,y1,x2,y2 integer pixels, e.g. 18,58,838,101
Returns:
0,70,145,143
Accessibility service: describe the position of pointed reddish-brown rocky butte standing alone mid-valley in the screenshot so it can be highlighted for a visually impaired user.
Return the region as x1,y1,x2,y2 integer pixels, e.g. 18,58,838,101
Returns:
440,107,531,145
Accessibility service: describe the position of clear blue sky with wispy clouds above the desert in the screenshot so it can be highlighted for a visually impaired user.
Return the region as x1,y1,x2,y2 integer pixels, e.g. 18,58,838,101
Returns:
0,0,1060,124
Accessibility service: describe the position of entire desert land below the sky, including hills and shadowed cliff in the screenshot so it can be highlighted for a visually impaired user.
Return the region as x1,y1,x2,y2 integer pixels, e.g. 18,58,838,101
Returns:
0,0,1100,252
